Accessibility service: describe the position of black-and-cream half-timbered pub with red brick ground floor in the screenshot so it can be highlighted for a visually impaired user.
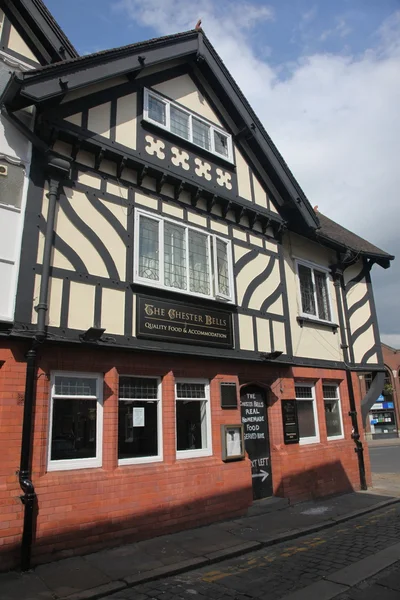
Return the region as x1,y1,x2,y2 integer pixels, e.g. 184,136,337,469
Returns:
0,0,393,568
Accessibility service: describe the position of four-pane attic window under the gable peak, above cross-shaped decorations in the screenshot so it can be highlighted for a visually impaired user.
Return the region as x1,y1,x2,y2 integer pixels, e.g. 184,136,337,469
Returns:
144,89,233,162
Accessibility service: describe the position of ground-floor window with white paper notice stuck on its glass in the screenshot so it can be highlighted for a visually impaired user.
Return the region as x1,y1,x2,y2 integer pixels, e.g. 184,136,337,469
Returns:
118,376,162,465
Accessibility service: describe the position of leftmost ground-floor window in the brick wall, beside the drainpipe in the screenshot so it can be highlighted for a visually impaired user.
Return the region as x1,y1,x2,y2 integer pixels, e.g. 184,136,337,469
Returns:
48,371,103,471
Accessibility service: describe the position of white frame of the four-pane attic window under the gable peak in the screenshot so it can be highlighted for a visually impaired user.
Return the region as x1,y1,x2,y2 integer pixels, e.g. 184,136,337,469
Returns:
143,88,234,164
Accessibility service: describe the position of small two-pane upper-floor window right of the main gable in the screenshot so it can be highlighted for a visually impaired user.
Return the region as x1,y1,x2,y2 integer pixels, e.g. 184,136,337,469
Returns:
297,261,332,323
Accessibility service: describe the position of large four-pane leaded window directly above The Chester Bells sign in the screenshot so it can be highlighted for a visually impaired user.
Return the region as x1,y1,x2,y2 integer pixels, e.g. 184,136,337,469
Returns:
134,210,233,301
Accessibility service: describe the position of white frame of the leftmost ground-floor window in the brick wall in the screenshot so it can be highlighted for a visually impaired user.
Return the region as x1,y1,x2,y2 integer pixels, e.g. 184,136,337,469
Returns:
47,371,104,471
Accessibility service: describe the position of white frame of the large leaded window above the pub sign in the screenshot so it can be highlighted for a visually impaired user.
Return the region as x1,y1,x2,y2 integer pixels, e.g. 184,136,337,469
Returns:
133,208,235,304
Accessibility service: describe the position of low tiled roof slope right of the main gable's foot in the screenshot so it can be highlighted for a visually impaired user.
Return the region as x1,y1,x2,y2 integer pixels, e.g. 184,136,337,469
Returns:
316,212,394,260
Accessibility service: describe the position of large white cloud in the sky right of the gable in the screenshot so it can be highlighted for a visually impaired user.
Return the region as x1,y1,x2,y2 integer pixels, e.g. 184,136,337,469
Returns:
118,0,400,334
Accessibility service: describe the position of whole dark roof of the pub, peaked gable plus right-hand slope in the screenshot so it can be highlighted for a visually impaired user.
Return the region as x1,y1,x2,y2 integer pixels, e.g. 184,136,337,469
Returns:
0,18,393,264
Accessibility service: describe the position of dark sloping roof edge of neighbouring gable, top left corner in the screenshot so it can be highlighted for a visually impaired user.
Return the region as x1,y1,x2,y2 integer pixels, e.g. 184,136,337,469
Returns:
0,0,78,65
